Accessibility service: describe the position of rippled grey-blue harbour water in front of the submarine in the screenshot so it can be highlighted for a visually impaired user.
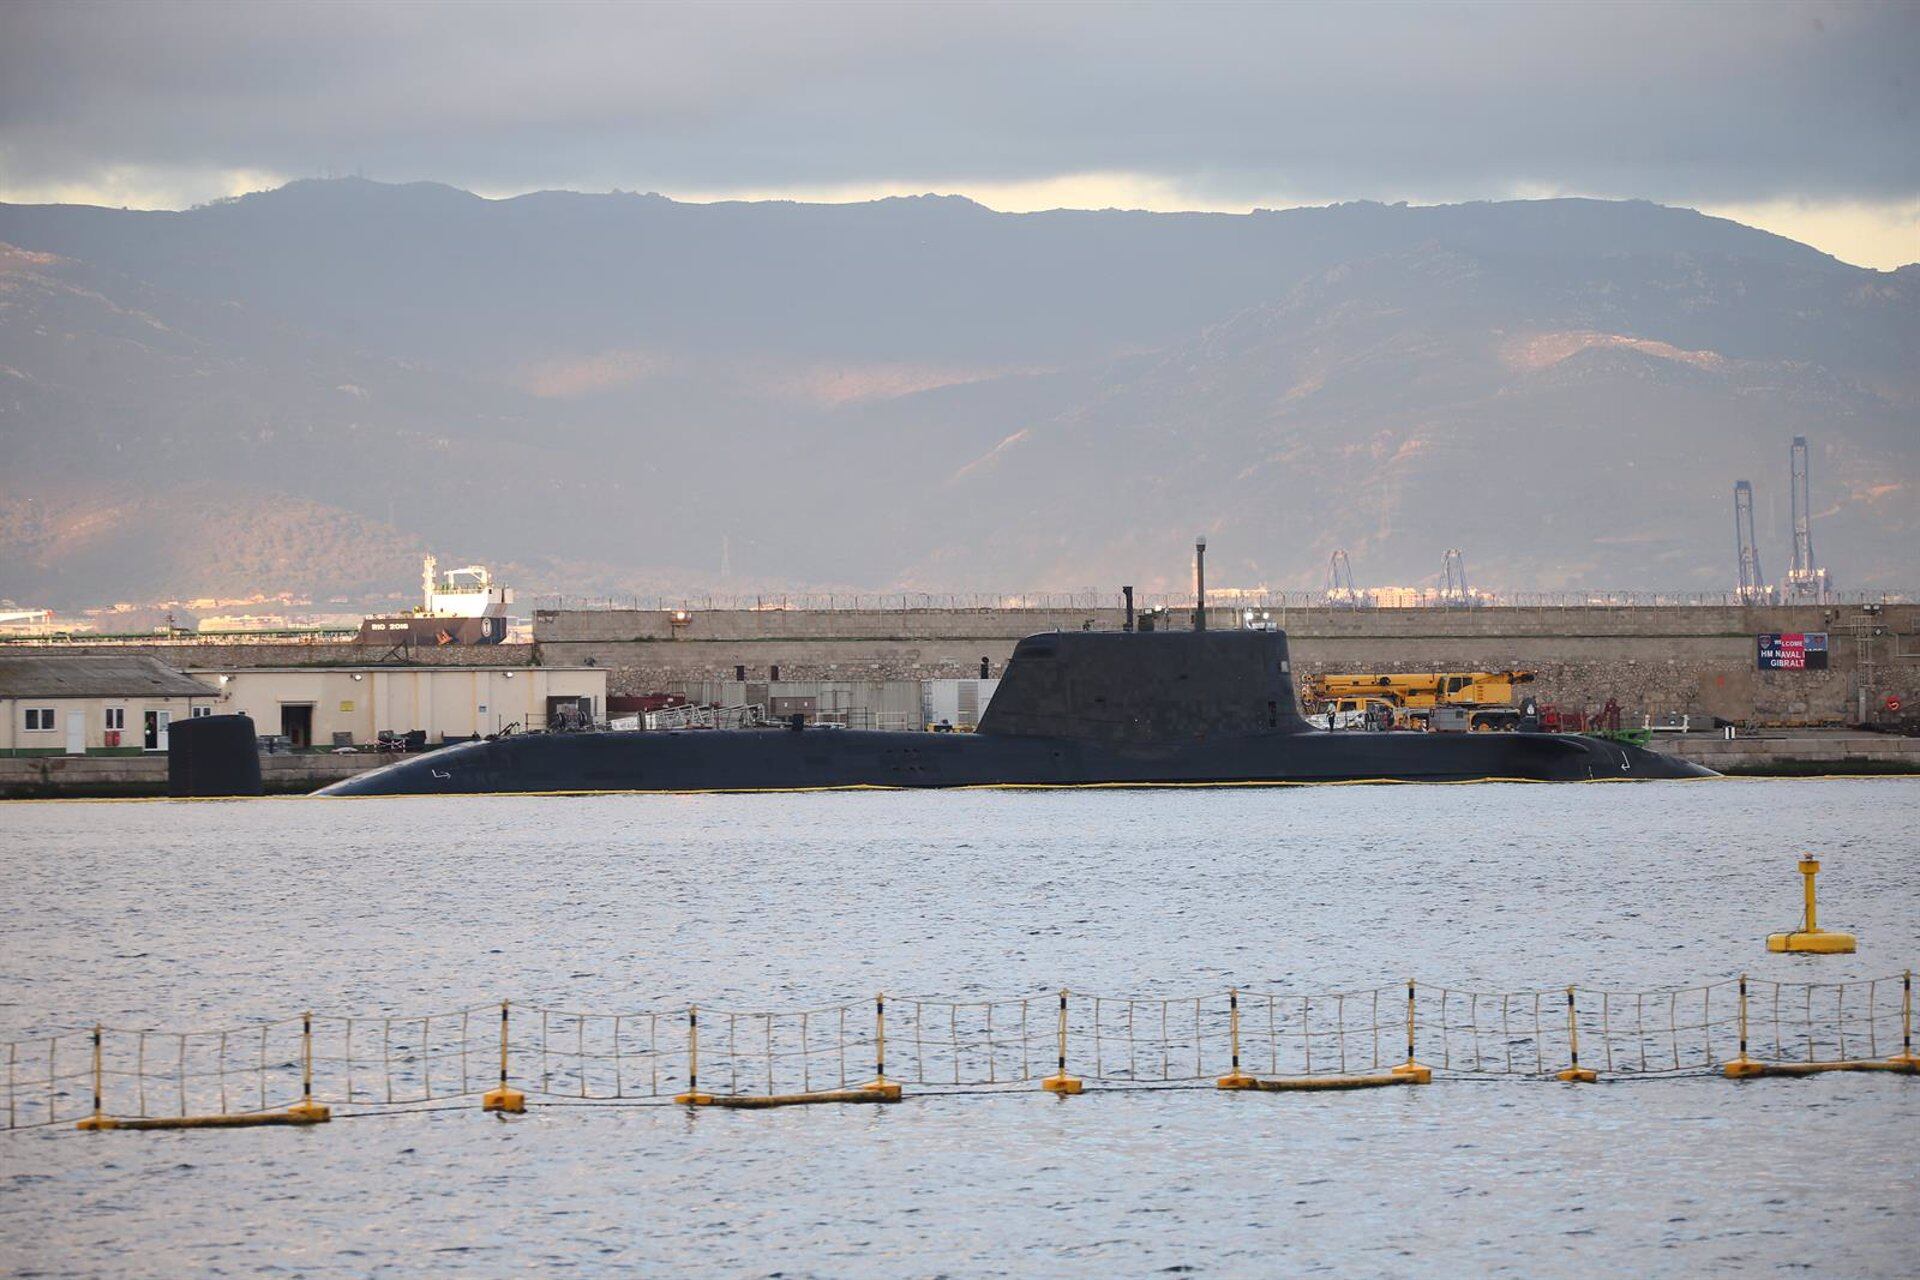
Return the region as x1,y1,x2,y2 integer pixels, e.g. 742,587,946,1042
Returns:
0,779,1920,1276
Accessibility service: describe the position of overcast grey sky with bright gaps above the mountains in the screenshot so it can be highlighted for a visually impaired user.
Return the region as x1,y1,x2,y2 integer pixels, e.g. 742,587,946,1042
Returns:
0,0,1920,267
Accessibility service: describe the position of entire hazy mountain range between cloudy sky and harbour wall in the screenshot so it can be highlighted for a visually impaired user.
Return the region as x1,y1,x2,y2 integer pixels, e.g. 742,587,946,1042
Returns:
0,180,1920,604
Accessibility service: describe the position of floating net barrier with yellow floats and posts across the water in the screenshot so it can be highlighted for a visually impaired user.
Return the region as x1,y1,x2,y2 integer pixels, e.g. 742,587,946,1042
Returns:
0,971,1920,1130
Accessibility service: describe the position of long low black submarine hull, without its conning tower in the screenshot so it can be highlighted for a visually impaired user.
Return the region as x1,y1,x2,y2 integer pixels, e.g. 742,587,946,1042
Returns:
319,729,1713,796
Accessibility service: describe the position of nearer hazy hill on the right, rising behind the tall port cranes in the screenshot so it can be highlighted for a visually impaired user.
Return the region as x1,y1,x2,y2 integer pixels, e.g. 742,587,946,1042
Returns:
902,249,1920,587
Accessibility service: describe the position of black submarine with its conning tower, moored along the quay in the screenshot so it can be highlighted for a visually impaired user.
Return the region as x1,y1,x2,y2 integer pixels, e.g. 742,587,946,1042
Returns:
317,629,1713,796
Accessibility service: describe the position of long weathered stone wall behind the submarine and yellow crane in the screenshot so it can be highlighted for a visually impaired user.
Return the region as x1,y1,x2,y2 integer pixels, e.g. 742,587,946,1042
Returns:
534,604,1920,725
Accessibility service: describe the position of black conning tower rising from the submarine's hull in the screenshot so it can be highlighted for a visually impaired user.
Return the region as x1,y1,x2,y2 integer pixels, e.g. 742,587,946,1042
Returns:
977,631,1309,745
